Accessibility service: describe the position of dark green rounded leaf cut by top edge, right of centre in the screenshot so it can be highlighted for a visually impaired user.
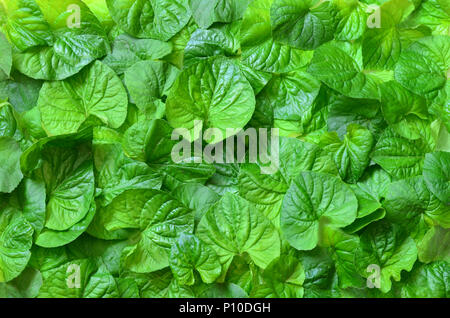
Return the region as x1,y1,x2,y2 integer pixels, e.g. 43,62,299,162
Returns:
270,0,338,50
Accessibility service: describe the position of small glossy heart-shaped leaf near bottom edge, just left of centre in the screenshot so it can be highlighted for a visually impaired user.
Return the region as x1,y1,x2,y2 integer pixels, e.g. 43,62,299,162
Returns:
169,233,222,285
